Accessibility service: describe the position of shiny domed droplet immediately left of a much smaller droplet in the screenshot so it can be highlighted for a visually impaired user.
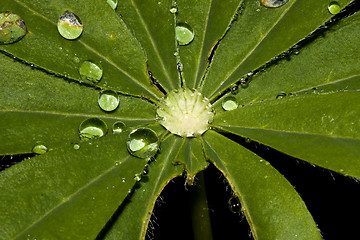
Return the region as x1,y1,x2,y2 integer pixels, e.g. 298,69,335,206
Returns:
79,118,108,141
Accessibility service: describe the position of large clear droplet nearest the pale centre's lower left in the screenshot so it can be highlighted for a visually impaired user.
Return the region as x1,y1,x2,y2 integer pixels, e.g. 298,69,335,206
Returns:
127,128,159,158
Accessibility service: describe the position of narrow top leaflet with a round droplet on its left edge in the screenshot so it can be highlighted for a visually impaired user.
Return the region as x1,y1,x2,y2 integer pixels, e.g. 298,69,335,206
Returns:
176,0,241,88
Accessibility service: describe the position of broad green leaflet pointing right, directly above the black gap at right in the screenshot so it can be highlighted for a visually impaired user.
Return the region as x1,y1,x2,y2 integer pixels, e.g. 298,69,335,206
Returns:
214,91,360,178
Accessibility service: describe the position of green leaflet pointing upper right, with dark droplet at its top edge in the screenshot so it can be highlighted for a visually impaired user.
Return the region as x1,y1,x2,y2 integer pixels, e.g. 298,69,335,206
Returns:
201,0,350,97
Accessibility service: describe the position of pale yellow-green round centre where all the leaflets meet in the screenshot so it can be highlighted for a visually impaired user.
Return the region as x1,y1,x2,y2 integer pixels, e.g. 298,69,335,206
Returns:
157,88,214,137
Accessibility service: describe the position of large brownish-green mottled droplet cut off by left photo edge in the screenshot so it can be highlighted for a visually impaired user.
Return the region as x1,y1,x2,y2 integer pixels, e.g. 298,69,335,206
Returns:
0,12,27,45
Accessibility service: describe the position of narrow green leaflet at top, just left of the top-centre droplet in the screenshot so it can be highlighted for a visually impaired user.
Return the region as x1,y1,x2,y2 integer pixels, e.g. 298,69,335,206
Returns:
117,0,180,92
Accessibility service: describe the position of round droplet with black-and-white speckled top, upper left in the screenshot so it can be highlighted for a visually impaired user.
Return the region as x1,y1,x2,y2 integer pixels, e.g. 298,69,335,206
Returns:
57,11,84,40
